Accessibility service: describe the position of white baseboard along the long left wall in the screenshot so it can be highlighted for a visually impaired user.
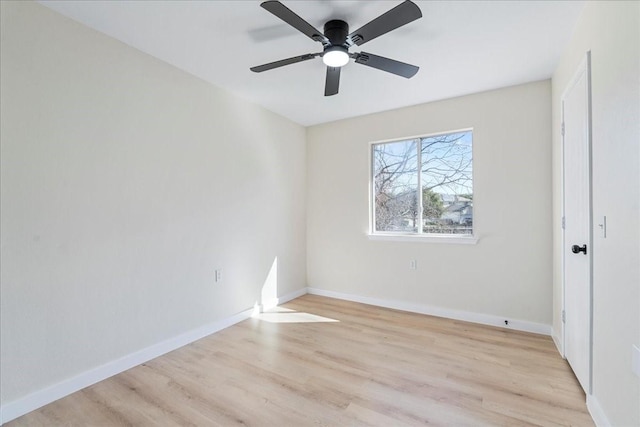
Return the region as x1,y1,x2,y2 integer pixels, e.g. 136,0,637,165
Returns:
0,288,307,425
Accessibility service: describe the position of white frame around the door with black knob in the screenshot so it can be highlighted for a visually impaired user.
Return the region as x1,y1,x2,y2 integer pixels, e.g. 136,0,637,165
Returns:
560,51,593,395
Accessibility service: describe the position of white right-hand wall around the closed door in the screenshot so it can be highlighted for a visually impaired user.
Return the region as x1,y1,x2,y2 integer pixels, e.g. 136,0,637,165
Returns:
553,1,640,426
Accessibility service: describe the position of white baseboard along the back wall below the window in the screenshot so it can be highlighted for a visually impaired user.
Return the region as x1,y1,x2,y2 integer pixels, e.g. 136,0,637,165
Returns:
307,288,551,335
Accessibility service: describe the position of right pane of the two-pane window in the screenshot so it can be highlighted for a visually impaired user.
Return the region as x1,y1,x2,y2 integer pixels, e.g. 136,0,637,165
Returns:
421,131,473,234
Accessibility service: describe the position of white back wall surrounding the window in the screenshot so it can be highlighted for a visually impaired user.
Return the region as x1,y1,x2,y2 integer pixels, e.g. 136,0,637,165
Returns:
307,81,552,325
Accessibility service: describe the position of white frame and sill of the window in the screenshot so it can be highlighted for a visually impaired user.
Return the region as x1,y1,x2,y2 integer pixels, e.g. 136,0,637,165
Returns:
367,128,479,245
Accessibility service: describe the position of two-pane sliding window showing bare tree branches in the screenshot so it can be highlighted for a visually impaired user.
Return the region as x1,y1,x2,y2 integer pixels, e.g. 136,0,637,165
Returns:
371,130,473,237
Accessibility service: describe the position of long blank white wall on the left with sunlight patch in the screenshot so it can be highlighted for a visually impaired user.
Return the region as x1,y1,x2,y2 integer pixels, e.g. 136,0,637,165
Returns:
0,1,306,412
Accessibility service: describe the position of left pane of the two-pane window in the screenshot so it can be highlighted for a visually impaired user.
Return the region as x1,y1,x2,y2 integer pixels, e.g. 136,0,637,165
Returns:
373,140,420,233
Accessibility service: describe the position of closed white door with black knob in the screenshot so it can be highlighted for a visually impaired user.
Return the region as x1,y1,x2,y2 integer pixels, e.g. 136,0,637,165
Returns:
562,53,592,394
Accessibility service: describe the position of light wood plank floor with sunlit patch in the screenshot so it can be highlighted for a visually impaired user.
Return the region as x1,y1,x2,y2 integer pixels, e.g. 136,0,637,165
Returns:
8,295,593,426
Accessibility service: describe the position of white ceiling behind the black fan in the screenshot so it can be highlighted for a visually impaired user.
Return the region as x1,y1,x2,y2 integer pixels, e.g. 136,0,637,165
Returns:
41,0,584,126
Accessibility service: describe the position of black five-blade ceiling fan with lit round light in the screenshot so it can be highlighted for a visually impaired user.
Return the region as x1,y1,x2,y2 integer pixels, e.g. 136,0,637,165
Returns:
251,0,422,96
